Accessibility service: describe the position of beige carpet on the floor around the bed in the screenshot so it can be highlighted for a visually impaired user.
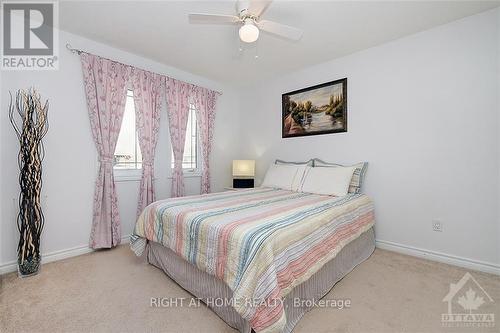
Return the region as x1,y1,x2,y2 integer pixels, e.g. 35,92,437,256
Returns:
0,246,500,333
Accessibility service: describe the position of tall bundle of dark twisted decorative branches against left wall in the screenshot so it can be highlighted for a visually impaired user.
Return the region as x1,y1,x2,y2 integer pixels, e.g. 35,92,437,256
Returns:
9,89,49,277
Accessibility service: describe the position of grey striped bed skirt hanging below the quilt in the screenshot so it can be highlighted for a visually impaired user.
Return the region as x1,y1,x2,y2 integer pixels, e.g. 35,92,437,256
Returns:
147,228,375,333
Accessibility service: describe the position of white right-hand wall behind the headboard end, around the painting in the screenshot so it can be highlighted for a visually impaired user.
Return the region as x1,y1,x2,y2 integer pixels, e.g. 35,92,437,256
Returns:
241,10,500,267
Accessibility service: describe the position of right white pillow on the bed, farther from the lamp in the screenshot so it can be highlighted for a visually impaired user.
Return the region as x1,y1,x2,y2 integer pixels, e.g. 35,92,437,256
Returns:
302,166,356,197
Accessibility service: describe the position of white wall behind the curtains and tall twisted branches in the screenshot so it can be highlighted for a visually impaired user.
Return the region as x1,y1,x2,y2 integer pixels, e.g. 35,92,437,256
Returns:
0,31,239,270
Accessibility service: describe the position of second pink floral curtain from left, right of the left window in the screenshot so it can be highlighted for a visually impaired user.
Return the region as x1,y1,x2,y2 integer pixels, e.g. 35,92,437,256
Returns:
132,69,161,216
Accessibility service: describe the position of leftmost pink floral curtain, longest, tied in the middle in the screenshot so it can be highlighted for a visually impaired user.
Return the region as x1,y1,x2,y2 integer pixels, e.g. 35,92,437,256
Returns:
80,53,130,249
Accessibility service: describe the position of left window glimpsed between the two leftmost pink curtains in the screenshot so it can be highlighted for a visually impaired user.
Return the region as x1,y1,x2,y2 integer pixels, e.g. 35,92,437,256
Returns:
114,90,142,170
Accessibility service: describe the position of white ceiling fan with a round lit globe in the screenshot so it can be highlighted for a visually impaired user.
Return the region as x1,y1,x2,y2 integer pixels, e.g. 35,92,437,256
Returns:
189,0,302,43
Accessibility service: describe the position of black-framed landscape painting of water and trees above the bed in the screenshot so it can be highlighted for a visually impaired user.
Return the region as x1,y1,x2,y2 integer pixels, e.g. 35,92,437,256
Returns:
281,78,347,138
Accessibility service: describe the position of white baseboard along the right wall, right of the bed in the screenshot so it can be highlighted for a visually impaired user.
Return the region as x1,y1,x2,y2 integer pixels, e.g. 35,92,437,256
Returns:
375,239,500,275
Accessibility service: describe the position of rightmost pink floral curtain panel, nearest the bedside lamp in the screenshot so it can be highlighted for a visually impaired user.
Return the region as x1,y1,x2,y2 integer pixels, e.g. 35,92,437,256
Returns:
193,87,218,194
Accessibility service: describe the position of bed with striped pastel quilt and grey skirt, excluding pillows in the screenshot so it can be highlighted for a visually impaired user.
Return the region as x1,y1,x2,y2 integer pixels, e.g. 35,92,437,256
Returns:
131,187,375,333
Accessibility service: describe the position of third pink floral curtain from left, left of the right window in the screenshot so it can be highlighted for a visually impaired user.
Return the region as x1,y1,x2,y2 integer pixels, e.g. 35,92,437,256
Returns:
165,77,191,197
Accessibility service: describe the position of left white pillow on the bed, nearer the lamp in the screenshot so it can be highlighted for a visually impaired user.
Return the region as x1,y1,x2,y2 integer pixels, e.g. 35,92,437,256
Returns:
262,164,307,191
